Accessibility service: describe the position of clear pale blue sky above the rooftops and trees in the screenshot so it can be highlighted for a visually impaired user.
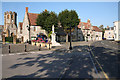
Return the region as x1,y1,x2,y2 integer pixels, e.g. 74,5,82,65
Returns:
0,2,118,27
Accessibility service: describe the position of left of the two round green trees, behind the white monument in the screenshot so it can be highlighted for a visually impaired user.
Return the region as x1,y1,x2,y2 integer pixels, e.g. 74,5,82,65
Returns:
36,10,58,33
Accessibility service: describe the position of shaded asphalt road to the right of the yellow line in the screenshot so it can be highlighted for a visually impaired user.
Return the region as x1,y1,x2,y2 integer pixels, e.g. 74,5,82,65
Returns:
91,40,120,79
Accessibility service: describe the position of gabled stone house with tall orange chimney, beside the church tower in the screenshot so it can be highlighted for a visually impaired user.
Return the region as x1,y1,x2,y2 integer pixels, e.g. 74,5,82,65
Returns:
17,7,47,42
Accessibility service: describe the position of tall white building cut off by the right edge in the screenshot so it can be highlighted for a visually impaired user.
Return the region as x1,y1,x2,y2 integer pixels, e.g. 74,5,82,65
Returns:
114,21,120,41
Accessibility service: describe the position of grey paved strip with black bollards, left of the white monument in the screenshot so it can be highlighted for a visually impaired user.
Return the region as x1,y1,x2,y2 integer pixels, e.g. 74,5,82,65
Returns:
2,44,50,54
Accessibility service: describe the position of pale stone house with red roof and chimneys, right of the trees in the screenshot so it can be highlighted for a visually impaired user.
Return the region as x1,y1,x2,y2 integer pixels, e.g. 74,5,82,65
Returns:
78,19,102,41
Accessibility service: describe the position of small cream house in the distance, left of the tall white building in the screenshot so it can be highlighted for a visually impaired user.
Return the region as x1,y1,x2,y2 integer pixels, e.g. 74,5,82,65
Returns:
104,26,114,40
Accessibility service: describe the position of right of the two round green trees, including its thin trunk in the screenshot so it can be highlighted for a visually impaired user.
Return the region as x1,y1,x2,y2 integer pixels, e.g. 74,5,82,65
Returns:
58,9,79,42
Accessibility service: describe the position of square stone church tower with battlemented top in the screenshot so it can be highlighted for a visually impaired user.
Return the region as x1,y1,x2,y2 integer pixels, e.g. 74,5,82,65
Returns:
3,11,17,37
